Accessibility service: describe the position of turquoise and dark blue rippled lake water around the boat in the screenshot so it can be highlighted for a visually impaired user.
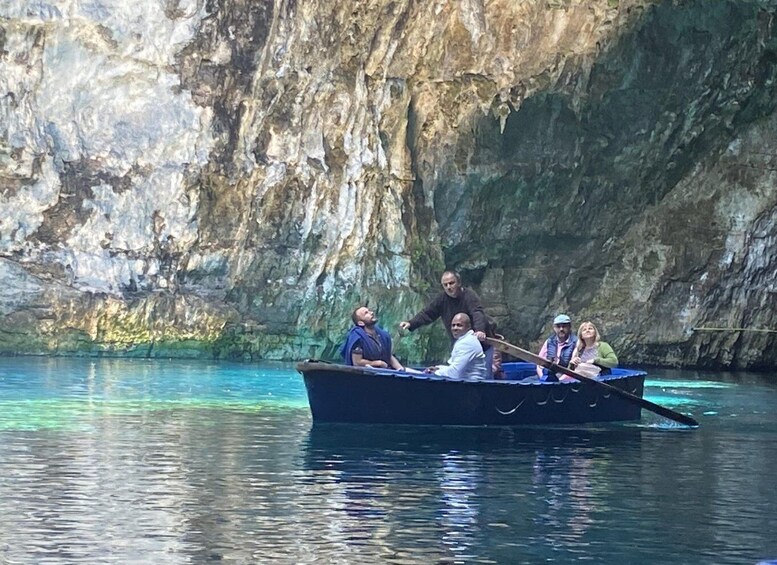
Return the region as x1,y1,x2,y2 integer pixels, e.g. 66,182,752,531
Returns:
0,358,777,565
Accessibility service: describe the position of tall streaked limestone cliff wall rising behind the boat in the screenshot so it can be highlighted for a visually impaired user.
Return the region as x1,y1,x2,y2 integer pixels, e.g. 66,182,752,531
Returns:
0,0,777,368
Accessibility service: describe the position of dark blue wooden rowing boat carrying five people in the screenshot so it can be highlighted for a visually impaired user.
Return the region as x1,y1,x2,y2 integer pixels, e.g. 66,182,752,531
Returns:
297,362,645,426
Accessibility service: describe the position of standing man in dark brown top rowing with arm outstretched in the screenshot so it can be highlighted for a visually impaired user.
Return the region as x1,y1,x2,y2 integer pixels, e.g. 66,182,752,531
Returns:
399,271,487,341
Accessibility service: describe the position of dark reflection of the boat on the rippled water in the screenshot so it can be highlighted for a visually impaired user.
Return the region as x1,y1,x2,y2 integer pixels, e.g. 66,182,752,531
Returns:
303,424,643,561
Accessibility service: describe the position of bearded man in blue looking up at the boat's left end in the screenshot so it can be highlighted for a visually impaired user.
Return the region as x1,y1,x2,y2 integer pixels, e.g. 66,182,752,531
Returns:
341,306,404,371
